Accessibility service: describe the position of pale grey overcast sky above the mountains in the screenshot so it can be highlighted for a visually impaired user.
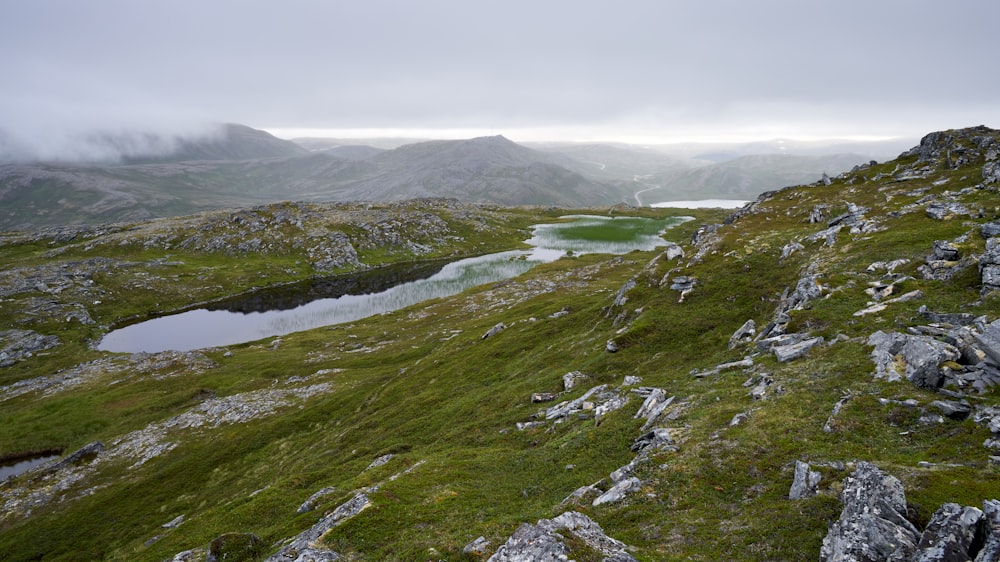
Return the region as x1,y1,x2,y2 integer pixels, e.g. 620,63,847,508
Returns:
0,0,1000,155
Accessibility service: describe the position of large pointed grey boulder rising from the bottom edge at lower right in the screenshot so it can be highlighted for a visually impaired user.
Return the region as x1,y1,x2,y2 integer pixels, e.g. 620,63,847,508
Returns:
820,462,920,562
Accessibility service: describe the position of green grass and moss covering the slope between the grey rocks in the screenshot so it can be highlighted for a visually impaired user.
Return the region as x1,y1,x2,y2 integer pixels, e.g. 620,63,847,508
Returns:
0,133,1000,560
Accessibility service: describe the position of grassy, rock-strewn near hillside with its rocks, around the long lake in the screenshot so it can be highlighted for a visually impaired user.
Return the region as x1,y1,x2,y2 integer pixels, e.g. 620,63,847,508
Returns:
0,127,1000,562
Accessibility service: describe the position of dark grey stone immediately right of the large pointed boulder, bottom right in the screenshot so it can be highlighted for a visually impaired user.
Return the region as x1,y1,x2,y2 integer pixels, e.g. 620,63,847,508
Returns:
910,503,983,562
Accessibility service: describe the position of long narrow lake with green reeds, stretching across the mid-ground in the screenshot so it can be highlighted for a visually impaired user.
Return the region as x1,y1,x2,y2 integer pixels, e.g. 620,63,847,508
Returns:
97,215,690,353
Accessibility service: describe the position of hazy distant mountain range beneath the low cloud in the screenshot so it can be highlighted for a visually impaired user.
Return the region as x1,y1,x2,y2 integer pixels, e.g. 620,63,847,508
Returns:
0,124,884,230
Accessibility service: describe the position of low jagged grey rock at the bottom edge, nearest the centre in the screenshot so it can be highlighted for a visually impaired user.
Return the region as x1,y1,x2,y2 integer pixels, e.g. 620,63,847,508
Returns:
489,511,635,562
